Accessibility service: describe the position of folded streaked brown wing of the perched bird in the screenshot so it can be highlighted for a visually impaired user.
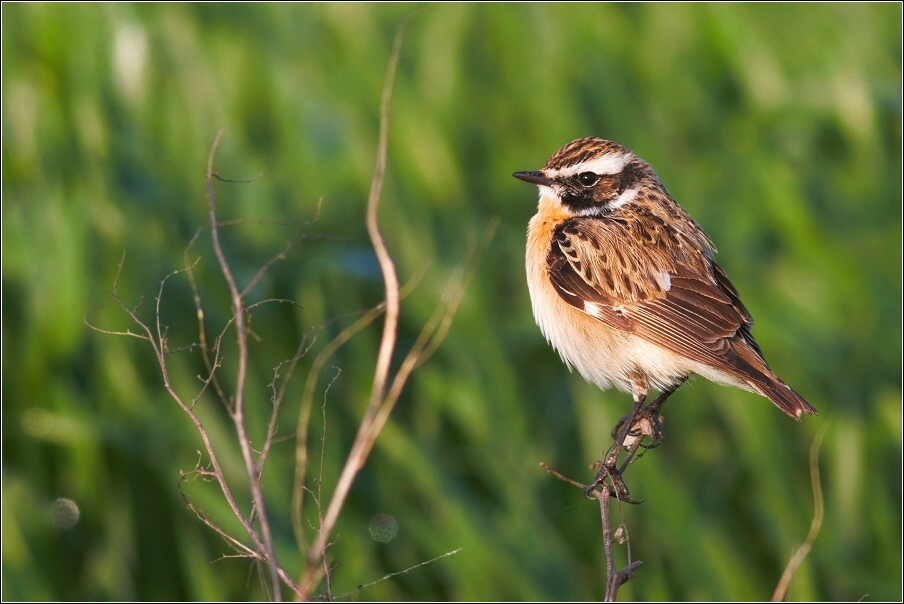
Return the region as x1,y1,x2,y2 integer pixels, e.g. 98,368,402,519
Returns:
548,212,765,373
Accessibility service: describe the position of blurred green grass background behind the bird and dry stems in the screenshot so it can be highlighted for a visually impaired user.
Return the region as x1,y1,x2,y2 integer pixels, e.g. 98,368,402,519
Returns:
2,3,902,600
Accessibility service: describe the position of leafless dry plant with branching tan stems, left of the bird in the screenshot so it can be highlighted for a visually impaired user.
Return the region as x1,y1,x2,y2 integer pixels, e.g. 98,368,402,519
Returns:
90,23,480,600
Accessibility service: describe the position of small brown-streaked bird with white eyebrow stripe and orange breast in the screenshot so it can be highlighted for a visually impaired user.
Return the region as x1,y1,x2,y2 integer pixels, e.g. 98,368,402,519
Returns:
513,138,816,419
